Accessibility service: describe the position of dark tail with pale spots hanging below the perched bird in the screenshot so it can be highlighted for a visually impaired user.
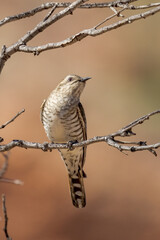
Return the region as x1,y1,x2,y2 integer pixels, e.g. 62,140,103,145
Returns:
69,171,86,208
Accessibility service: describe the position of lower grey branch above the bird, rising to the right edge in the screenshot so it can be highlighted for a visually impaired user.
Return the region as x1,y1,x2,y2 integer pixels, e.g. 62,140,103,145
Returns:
18,6,160,55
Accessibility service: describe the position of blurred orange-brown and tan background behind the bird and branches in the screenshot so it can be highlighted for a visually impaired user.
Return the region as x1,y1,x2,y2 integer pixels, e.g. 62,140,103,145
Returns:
0,0,160,240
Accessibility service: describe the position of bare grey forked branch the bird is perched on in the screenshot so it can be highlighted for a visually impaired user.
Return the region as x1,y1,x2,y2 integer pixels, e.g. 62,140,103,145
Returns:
0,110,160,156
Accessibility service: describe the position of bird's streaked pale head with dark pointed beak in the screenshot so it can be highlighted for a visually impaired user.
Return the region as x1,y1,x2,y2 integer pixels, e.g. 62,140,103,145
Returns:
57,75,90,98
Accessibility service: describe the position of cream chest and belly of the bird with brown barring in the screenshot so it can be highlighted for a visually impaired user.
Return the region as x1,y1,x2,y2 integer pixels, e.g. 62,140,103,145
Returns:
43,90,83,143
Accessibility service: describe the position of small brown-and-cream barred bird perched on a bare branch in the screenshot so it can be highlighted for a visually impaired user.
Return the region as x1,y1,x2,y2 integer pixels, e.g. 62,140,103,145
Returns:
40,74,91,208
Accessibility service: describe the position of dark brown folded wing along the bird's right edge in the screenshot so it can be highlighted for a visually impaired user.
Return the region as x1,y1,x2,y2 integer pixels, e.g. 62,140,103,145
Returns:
78,102,87,166
